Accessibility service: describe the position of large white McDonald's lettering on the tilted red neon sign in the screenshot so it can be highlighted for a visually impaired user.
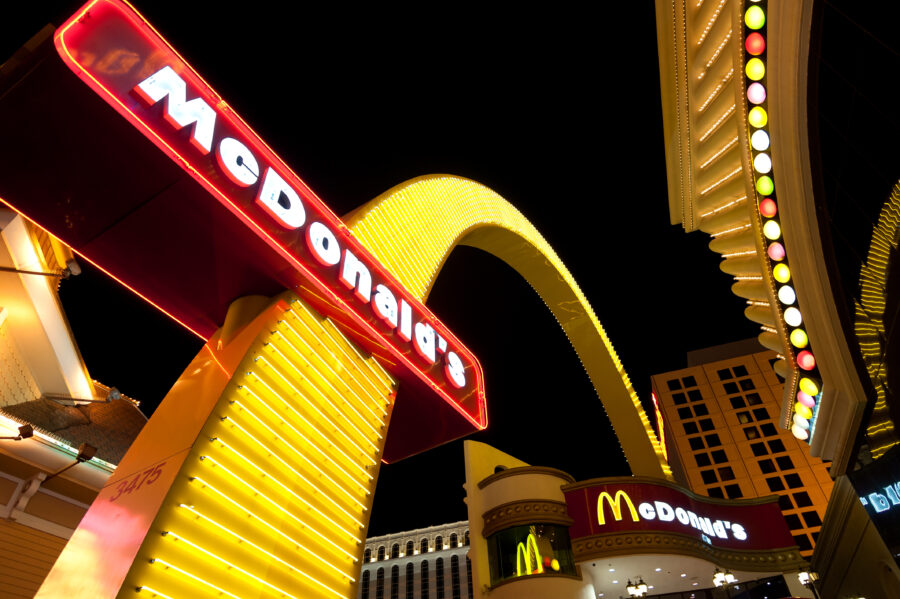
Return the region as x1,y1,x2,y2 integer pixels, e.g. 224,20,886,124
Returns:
132,66,466,389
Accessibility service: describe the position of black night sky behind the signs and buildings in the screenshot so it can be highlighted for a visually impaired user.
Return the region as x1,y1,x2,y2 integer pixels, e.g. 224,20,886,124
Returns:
0,0,756,535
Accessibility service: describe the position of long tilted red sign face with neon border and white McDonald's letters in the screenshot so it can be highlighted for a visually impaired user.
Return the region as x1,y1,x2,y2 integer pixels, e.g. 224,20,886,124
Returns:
54,0,487,429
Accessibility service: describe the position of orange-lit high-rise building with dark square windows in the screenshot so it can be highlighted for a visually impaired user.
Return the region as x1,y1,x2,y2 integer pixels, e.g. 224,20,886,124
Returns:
652,339,833,558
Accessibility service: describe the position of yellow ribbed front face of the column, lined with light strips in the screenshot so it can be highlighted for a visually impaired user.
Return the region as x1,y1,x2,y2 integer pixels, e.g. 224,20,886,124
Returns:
120,294,396,599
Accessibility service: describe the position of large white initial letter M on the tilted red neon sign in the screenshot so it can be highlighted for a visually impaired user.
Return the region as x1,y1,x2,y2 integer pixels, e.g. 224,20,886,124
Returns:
134,66,216,154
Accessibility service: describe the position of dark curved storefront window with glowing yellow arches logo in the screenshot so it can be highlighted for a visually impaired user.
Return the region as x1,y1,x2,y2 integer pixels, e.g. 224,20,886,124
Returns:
488,524,576,585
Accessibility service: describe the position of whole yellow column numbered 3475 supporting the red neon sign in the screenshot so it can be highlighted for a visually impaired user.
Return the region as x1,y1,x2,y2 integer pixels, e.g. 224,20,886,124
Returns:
38,293,397,599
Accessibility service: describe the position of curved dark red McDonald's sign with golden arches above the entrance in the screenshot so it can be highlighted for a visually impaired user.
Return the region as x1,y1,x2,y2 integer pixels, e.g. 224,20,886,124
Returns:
564,478,795,550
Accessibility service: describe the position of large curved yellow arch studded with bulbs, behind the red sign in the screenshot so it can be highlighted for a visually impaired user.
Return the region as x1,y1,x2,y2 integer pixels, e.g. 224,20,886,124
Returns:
344,175,671,478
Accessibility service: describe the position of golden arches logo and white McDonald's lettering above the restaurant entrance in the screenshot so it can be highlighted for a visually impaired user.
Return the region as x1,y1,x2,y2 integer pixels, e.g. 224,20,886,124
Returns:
597,489,748,542
